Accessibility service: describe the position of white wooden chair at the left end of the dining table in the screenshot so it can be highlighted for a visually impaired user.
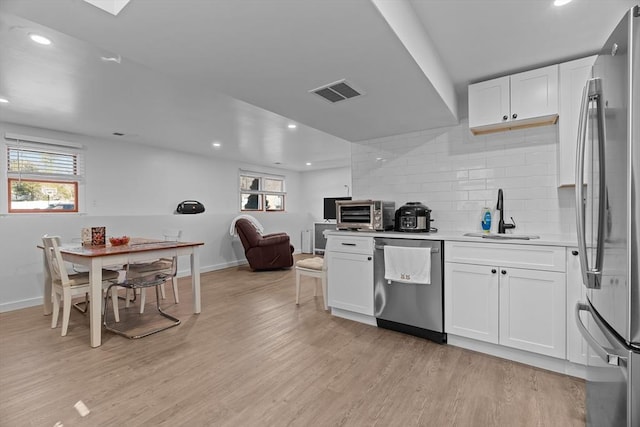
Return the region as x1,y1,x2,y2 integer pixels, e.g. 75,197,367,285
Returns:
42,235,120,337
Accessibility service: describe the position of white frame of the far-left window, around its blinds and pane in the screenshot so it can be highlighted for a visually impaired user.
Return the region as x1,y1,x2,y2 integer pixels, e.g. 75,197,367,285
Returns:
2,133,85,214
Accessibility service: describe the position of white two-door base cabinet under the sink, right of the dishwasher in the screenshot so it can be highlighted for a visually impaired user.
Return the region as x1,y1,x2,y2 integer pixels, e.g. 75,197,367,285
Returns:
445,242,566,359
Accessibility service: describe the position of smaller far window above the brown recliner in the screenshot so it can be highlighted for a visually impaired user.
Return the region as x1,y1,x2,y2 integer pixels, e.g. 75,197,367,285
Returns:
240,171,286,212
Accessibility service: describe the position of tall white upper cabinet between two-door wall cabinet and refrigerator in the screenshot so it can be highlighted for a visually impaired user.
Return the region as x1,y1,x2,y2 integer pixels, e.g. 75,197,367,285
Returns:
558,55,597,187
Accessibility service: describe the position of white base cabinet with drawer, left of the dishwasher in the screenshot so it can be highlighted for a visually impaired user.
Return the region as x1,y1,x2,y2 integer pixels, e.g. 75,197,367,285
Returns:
325,236,373,316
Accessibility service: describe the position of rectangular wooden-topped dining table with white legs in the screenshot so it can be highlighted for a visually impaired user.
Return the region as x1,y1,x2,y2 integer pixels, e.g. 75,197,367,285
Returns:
40,237,204,347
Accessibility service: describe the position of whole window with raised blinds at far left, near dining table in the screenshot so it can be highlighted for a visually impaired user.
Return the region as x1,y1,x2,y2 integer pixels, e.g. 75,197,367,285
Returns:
5,135,84,213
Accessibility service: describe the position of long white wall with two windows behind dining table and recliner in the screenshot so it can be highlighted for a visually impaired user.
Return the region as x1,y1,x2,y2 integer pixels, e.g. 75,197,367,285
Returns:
0,123,313,311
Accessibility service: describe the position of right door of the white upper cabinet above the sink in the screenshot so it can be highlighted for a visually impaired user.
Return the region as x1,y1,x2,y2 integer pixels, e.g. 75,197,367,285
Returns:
509,65,558,121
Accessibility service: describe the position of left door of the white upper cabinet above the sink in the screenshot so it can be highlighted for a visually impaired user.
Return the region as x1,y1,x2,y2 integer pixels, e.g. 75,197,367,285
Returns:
469,76,509,128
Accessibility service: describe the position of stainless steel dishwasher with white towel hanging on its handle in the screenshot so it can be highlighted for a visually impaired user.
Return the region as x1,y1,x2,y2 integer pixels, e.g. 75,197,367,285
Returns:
373,237,447,343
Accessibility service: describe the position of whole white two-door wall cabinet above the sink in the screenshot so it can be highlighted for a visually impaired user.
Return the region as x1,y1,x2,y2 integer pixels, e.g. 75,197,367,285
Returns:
469,65,558,135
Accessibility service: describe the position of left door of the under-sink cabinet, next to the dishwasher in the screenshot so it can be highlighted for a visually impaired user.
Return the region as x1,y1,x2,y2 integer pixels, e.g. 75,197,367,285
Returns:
444,262,498,344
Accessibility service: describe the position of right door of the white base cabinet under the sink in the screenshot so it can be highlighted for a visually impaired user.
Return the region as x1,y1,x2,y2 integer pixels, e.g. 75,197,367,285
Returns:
500,268,566,359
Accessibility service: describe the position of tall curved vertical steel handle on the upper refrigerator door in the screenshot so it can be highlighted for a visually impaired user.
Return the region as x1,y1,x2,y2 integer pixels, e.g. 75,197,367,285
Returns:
576,78,607,289
